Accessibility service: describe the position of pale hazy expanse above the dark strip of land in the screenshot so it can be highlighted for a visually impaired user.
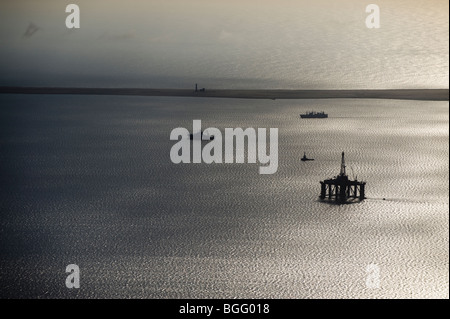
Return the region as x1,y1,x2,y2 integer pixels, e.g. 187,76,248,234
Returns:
0,0,449,88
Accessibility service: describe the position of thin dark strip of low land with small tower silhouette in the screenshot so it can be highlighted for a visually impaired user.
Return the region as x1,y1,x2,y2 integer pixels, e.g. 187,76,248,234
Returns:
0,87,449,101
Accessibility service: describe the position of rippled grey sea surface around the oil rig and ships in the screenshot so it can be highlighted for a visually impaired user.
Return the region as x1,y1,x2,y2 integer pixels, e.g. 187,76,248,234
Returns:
0,95,449,298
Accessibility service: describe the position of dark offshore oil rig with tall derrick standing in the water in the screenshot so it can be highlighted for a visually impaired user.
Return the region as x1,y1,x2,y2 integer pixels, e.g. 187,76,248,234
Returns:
320,152,366,204
